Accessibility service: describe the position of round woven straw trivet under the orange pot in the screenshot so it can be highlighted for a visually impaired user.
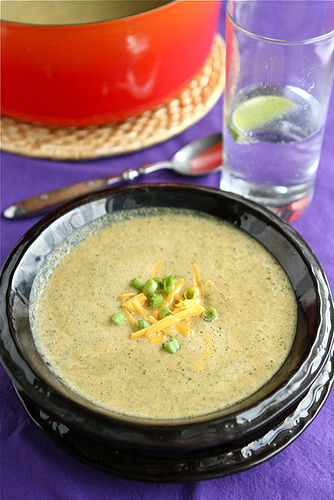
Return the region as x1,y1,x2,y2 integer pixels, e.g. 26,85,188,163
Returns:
1,34,225,160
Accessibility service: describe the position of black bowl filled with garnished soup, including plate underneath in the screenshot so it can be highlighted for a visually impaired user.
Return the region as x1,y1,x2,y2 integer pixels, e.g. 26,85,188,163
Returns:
1,184,333,481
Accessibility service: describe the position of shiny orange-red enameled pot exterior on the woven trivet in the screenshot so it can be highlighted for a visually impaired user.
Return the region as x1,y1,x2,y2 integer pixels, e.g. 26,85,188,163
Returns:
1,0,221,126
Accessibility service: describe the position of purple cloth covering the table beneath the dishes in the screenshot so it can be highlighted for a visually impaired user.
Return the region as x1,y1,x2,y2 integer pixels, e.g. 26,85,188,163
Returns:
0,4,334,500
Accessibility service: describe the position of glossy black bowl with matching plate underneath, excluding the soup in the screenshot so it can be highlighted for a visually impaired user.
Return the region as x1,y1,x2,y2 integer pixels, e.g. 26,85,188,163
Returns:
0,184,334,481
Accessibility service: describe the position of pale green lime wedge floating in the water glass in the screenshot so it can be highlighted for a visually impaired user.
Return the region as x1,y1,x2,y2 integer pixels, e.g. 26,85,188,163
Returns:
231,95,297,133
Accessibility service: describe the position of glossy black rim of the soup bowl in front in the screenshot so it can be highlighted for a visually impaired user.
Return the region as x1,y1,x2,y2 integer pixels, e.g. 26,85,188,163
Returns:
0,183,334,449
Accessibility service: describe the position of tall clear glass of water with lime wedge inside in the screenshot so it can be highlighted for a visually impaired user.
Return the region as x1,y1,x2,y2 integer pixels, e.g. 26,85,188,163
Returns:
221,0,334,221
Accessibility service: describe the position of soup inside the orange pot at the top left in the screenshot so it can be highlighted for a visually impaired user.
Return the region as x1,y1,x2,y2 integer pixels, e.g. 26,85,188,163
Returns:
1,0,171,25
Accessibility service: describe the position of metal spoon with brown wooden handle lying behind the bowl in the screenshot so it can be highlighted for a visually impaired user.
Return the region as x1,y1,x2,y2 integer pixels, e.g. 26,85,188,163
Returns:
3,133,223,219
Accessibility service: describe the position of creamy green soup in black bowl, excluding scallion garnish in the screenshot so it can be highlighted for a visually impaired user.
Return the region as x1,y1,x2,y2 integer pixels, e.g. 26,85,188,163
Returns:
31,210,297,419
